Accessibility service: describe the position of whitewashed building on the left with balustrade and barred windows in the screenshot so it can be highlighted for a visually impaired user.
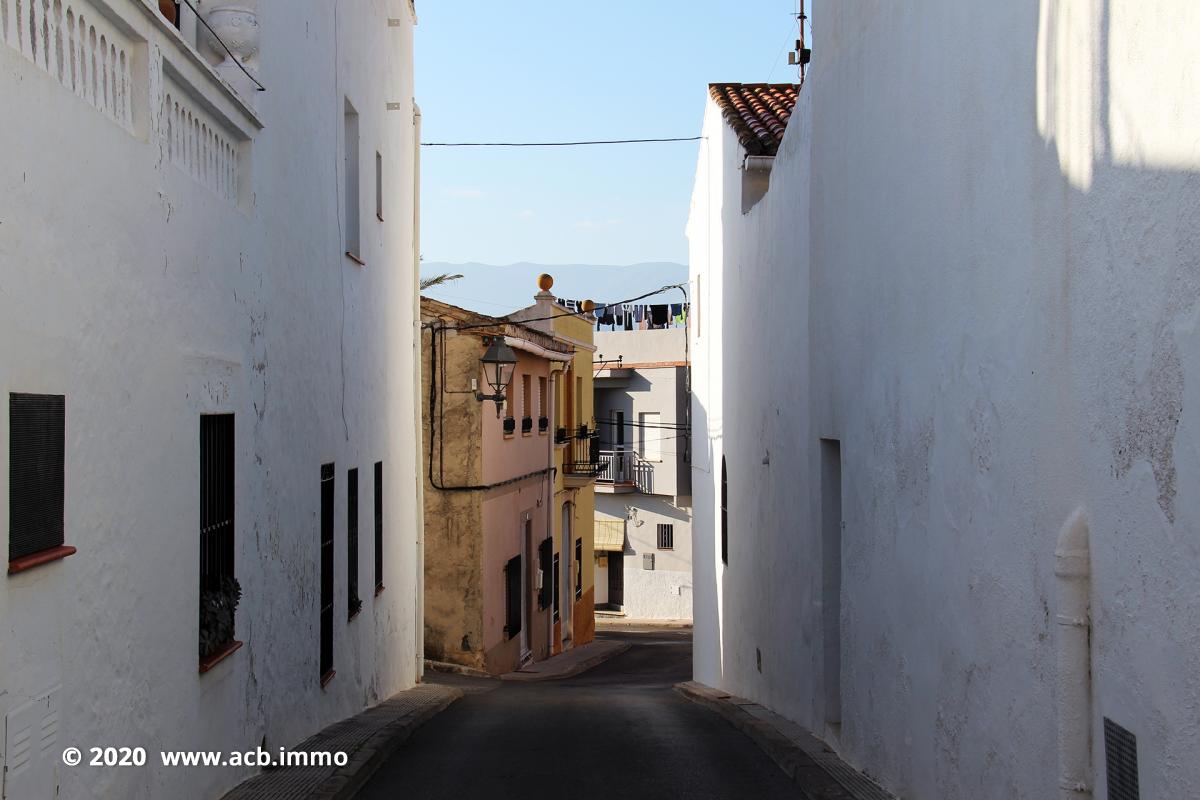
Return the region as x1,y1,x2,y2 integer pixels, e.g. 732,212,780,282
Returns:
0,0,422,800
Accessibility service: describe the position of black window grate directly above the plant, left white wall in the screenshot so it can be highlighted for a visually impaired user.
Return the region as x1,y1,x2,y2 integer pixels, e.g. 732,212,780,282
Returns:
200,414,234,591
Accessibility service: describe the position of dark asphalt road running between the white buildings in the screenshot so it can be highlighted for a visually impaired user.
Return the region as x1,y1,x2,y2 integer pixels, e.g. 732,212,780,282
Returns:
359,630,803,800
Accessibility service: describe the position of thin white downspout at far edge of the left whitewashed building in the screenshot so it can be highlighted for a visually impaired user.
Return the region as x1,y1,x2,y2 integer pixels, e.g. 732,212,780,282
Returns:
413,102,436,682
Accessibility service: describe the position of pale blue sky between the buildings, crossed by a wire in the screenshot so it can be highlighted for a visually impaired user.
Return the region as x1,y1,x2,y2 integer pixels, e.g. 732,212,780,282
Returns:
416,0,797,264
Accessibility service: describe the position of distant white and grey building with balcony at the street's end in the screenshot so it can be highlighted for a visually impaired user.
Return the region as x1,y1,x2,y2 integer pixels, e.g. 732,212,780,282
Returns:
595,327,692,620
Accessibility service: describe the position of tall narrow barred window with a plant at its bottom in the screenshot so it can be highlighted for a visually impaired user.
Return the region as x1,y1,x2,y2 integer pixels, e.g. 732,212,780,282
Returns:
199,414,241,667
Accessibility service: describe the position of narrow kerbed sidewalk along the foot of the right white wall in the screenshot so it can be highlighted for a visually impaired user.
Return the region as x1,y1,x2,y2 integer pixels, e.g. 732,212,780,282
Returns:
674,681,890,800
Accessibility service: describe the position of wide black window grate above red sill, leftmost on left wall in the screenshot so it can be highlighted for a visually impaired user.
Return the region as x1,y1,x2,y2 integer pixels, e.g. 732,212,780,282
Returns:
8,393,66,561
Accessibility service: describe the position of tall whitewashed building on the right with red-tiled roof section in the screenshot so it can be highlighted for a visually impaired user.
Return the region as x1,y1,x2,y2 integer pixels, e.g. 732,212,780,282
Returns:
689,0,1200,800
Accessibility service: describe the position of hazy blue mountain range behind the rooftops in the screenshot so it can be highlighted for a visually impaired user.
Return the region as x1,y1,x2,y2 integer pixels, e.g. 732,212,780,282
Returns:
421,261,688,317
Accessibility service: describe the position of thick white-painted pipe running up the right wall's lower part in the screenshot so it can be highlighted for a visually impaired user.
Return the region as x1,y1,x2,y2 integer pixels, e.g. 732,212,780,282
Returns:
1054,509,1093,800
